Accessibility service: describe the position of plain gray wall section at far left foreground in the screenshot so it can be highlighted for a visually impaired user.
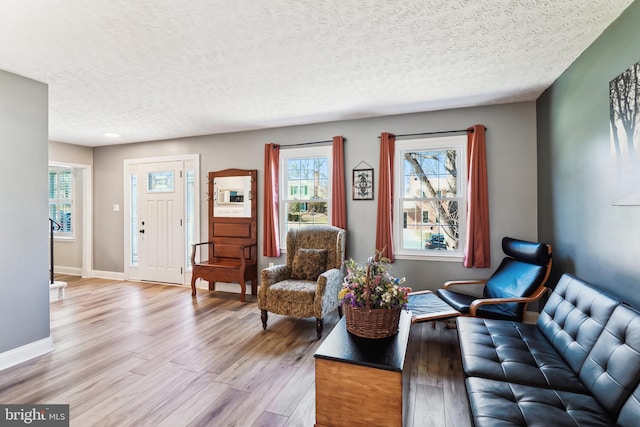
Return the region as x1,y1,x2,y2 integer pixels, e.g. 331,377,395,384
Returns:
0,70,49,353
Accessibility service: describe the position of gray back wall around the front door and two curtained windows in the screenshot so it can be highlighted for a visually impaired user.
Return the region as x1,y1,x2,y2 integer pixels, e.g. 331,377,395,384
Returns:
93,102,537,289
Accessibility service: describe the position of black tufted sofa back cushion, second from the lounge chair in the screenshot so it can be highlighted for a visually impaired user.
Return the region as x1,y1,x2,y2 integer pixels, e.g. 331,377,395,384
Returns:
579,305,640,414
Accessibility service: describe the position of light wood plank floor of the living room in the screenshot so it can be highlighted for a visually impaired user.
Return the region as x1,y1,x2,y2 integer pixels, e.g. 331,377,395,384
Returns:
0,276,470,427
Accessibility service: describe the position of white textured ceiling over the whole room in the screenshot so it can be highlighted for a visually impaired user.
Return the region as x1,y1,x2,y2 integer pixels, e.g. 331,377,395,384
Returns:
0,0,633,146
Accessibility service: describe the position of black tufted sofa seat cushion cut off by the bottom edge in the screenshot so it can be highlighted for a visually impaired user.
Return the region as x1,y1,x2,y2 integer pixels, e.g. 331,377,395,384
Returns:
466,378,615,427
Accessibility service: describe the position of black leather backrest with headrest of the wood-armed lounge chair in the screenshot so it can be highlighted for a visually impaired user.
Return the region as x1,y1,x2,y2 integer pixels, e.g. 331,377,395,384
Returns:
483,237,551,319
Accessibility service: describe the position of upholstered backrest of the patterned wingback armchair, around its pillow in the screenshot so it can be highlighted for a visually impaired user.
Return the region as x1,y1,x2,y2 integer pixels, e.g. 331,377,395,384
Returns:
287,225,346,270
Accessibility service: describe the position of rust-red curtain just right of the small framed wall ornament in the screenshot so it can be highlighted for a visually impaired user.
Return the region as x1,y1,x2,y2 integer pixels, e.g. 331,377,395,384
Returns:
376,132,396,261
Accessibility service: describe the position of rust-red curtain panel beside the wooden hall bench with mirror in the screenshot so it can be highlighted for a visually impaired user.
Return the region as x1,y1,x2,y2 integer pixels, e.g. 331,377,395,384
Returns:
262,144,280,257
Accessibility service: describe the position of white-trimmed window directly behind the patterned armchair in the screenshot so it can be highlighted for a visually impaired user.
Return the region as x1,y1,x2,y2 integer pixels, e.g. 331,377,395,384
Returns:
279,146,332,250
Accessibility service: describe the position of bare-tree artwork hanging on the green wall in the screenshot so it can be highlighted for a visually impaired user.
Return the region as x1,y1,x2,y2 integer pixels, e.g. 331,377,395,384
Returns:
609,62,640,206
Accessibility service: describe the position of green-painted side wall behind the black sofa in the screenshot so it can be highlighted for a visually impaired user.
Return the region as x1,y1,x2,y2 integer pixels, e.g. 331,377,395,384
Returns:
537,1,640,306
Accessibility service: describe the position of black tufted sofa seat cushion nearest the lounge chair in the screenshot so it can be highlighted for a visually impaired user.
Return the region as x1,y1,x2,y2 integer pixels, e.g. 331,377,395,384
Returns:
457,317,587,393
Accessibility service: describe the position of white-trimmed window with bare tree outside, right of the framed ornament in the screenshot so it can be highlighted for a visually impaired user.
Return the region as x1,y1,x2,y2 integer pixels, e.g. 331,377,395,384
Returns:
394,136,467,260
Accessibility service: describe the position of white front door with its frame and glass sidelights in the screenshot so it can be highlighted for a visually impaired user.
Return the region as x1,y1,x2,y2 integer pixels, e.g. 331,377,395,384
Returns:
124,155,199,285
